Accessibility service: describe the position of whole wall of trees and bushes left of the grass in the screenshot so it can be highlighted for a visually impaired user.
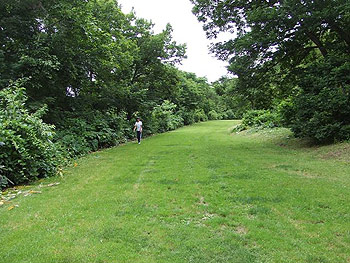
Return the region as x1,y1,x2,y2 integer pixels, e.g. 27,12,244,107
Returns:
0,0,238,190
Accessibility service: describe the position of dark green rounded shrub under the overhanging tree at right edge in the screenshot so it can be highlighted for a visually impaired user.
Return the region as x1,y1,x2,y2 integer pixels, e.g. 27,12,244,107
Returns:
283,57,350,143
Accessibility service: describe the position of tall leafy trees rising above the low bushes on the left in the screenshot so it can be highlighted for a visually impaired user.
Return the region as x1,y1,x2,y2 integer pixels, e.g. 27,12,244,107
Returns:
0,0,185,117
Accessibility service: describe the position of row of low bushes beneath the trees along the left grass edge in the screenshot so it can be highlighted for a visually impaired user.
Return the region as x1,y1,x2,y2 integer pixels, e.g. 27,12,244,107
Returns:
0,85,217,188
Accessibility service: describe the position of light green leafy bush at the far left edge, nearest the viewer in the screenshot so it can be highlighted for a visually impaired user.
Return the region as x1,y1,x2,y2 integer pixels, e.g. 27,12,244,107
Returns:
0,82,63,187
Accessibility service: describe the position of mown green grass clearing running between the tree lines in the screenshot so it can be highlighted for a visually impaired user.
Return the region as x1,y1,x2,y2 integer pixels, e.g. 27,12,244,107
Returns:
0,121,350,263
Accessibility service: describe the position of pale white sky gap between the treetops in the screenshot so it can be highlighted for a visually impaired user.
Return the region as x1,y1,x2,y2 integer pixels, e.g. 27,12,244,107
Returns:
118,0,227,82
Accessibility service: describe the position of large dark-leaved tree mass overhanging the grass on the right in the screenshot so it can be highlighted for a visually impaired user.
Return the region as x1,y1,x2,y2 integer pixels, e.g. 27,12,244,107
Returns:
192,0,350,143
